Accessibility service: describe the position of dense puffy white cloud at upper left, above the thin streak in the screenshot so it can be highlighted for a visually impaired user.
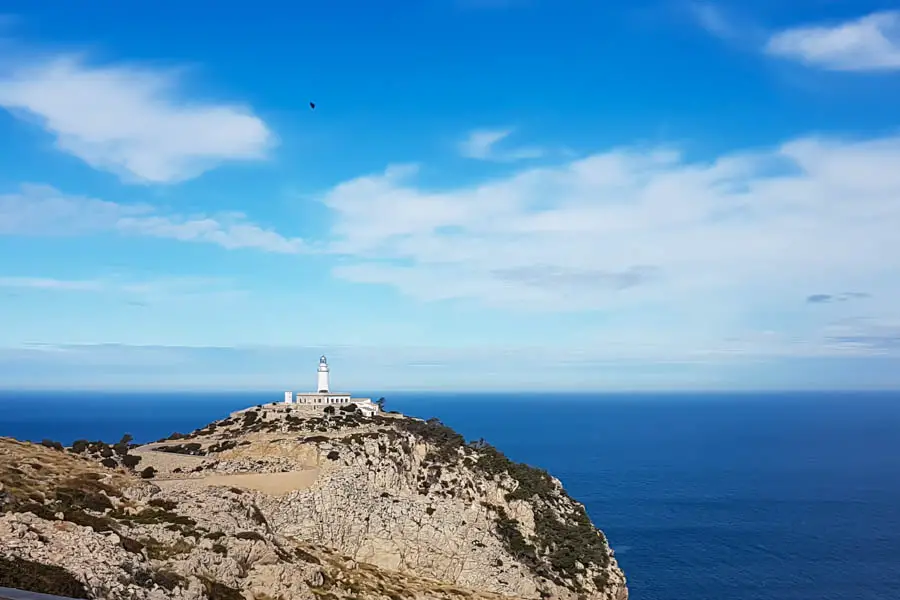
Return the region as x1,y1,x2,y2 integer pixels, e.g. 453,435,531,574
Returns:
0,55,275,183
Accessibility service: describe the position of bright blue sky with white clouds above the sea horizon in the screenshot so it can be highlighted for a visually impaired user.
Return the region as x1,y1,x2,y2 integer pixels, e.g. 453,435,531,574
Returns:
0,0,900,391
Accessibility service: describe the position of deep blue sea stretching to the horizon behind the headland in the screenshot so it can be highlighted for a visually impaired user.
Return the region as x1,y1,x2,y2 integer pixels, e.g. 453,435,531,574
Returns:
0,391,900,600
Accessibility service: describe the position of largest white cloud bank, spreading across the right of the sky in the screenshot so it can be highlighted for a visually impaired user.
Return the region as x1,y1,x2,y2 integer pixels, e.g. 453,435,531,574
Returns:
322,131,900,352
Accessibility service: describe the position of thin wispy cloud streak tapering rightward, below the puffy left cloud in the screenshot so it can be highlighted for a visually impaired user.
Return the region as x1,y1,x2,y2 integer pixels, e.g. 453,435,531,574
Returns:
0,185,304,254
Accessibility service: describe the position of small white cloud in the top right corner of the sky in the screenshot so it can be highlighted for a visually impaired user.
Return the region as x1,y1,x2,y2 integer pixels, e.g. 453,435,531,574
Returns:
765,11,900,71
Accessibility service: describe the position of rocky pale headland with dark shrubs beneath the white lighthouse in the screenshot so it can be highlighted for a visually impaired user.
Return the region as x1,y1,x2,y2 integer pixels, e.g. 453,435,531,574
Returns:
0,405,628,600
